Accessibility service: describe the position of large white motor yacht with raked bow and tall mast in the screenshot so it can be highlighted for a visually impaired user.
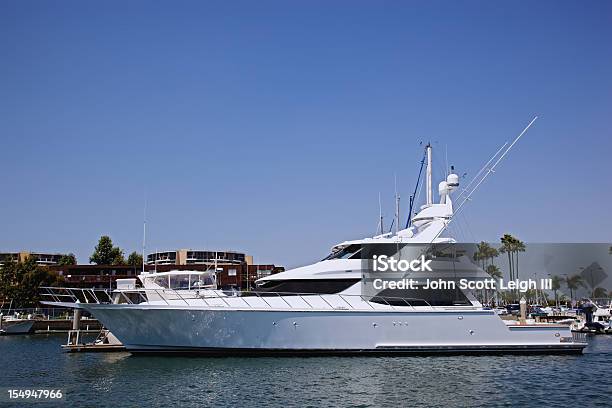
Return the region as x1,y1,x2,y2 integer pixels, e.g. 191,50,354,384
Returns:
45,139,586,355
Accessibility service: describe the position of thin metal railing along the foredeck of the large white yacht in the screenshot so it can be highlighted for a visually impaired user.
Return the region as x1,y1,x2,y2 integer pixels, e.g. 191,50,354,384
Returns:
40,287,444,310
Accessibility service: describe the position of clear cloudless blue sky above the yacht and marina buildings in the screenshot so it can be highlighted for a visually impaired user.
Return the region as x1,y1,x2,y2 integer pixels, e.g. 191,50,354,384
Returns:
0,1,612,266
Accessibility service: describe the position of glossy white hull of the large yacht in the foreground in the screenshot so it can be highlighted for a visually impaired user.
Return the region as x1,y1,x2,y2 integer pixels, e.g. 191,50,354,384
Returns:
82,304,586,355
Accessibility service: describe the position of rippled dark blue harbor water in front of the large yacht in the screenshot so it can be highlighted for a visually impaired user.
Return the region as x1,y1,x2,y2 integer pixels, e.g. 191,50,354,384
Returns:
0,335,612,407
